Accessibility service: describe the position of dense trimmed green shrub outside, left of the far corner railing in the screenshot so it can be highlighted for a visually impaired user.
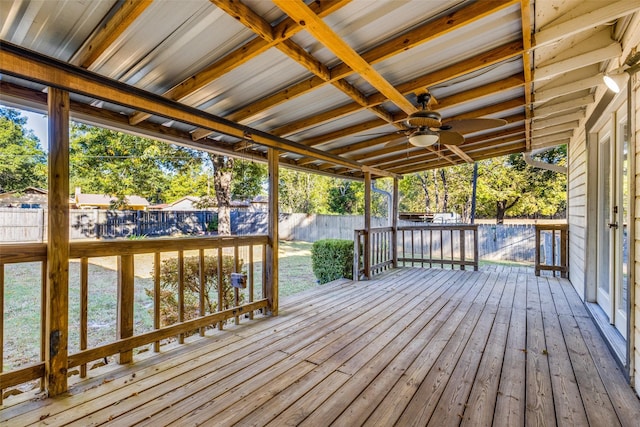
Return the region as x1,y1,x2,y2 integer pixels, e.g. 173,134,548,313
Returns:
311,239,353,284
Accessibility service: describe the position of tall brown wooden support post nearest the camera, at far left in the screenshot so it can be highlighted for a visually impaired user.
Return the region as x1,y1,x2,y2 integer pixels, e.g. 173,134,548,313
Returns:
44,87,69,396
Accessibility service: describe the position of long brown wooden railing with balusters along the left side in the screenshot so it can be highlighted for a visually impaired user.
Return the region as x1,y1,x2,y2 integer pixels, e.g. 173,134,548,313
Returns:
0,236,269,403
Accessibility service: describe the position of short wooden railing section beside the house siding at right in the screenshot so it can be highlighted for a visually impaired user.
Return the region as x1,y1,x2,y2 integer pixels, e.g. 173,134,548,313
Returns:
535,224,569,278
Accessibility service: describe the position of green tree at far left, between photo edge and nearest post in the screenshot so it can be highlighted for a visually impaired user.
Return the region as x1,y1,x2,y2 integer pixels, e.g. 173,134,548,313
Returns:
0,107,47,193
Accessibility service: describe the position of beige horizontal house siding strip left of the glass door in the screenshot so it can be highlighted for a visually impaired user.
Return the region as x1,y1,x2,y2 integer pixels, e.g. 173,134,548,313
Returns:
567,127,587,300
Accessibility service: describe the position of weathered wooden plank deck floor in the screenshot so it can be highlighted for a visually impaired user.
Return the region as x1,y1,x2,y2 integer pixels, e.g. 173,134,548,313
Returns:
0,268,640,426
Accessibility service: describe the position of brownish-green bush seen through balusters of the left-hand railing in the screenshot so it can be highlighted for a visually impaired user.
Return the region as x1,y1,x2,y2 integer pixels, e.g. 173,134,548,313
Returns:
145,256,244,325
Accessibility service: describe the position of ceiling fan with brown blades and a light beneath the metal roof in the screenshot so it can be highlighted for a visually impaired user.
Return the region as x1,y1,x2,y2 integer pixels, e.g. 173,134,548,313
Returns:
403,92,507,147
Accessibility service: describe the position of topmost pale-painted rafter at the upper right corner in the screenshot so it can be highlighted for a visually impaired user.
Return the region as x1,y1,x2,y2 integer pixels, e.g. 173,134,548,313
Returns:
535,0,640,49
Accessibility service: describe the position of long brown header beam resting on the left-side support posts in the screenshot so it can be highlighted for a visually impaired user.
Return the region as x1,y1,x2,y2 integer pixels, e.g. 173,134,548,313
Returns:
0,45,396,181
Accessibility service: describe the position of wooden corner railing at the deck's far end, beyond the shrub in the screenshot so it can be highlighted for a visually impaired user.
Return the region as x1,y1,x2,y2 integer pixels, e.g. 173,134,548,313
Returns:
353,224,478,279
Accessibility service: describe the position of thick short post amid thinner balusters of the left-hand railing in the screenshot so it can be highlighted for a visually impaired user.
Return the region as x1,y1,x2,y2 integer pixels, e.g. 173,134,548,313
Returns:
116,255,134,365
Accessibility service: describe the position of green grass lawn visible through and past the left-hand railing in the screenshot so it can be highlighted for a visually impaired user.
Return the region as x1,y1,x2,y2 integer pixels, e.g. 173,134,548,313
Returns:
3,241,318,370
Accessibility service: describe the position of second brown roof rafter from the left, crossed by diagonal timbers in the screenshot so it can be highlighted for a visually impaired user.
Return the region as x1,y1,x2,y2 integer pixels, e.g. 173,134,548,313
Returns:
130,0,351,124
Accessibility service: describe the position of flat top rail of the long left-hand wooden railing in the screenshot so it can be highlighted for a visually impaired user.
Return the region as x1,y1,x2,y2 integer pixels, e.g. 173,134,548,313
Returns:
0,235,268,264
